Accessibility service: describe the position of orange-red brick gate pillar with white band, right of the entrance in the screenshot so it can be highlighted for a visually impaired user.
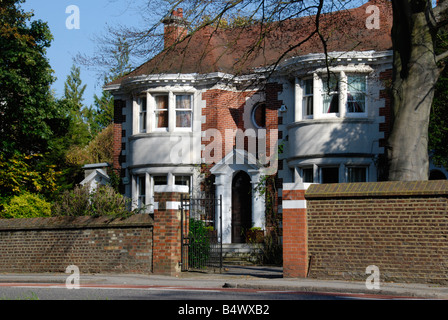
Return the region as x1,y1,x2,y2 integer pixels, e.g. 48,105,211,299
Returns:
282,183,309,278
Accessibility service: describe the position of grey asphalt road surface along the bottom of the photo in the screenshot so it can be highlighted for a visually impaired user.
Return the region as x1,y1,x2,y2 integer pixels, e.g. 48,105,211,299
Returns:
0,283,408,301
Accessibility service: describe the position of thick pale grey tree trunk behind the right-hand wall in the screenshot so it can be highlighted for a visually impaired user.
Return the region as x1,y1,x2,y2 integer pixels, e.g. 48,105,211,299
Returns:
387,0,448,181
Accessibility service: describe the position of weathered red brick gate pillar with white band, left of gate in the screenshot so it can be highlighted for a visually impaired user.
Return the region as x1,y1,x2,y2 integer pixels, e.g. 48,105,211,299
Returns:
152,192,187,276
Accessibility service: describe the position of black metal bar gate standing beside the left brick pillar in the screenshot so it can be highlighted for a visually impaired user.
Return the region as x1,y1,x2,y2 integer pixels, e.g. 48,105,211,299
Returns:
181,196,222,272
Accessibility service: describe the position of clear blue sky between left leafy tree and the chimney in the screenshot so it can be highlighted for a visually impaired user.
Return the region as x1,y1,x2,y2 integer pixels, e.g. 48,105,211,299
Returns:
22,0,144,106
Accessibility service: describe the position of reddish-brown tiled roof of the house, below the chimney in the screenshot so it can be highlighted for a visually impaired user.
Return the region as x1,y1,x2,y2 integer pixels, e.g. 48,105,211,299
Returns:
110,0,392,84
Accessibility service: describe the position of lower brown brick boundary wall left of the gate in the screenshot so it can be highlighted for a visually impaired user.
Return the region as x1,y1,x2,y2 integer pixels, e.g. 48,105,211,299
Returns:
0,215,154,273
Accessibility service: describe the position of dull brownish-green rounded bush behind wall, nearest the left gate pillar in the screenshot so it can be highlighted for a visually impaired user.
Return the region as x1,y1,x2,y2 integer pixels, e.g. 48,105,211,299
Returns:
52,186,132,218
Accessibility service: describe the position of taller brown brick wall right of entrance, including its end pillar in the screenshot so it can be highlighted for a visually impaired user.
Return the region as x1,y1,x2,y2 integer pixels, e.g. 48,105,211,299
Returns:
283,180,448,284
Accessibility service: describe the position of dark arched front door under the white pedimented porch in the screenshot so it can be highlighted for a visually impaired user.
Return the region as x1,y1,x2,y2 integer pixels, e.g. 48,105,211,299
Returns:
232,171,252,243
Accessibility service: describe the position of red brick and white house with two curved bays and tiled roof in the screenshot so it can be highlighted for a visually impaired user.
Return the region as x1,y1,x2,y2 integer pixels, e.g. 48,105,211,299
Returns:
105,0,393,243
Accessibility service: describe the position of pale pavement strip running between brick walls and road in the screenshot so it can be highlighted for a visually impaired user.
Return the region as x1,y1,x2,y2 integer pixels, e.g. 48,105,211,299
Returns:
0,266,448,300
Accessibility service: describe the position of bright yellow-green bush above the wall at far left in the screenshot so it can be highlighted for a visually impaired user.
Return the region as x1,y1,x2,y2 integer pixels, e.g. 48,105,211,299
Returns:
0,192,51,219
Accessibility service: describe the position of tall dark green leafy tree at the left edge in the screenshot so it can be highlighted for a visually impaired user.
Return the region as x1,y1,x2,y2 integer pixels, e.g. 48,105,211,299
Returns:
0,0,61,154
